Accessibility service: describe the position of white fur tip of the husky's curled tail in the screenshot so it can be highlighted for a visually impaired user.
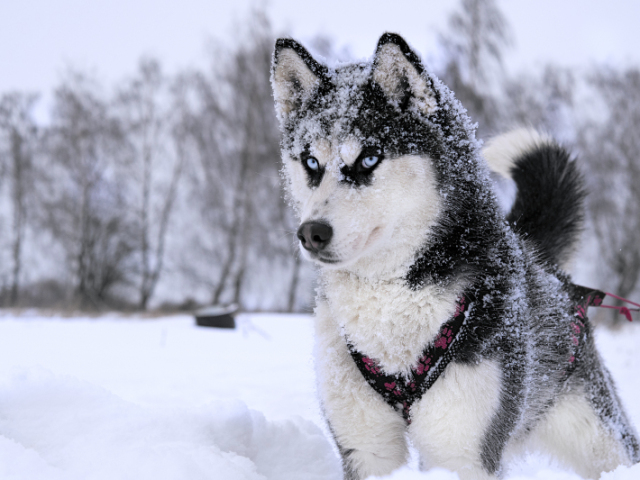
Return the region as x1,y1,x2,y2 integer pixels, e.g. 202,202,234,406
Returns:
482,128,555,178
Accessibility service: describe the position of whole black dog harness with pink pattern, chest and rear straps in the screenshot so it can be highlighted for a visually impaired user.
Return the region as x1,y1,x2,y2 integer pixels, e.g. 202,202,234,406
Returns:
347,284,640,424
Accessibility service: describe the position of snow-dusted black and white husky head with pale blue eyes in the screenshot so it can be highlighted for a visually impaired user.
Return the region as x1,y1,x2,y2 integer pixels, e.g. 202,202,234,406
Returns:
272,33,480,280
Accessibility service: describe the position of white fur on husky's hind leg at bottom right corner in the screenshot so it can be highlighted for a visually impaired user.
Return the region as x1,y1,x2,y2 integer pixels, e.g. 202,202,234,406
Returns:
528,389,631,478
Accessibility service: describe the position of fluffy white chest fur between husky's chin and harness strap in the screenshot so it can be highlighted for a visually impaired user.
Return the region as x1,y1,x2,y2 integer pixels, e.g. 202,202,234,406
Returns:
322,271,461,374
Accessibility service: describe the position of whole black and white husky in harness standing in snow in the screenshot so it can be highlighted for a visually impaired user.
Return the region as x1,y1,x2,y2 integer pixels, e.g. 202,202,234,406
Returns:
271,33,640,480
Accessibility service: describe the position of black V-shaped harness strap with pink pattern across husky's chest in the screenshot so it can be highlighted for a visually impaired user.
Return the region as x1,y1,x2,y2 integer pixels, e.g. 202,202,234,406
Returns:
347,294,473,424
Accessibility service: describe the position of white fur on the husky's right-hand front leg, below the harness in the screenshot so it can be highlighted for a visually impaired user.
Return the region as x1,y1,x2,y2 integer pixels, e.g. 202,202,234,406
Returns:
409,360,502,480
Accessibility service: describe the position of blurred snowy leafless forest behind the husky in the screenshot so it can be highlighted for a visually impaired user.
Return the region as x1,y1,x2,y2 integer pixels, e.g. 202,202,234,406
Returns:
0,0,640,320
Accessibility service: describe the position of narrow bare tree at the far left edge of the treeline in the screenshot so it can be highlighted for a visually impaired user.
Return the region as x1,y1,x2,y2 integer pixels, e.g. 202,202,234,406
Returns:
0,92,37,305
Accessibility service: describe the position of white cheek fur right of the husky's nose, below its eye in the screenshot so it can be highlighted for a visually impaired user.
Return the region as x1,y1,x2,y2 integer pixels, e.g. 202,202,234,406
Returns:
326,156,440,277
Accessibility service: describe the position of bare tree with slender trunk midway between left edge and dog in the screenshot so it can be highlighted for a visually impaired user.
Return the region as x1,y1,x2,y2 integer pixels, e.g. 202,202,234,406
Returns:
116,59,183,310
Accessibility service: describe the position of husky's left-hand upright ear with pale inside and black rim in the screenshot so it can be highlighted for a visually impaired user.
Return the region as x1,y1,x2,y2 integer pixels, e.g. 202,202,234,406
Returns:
271,38,327,121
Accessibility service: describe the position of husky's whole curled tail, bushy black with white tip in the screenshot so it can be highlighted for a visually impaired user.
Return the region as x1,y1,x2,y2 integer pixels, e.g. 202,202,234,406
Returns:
483,129,585,265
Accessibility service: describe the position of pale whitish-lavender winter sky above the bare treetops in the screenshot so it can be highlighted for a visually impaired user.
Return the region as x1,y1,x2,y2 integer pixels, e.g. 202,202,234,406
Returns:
0,0,640,99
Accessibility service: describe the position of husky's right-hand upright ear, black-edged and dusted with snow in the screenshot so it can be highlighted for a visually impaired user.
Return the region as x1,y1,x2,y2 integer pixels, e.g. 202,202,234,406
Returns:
373,33,437,115
